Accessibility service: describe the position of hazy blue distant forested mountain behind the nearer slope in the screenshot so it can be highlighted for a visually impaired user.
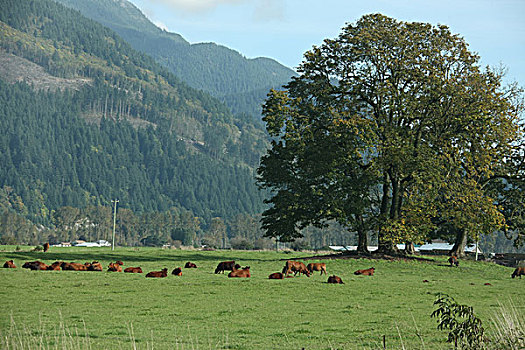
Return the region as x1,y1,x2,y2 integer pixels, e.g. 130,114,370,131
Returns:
57,0,296,116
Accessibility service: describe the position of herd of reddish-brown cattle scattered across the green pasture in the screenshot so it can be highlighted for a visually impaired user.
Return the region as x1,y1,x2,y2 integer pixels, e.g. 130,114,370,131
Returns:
4,256,525,284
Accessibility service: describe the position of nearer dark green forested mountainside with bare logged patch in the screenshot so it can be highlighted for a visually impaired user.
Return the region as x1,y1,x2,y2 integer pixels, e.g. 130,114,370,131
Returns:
0,0,267,230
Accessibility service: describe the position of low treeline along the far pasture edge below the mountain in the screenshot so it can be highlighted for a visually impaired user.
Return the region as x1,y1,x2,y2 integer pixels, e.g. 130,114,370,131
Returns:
0,196,356,250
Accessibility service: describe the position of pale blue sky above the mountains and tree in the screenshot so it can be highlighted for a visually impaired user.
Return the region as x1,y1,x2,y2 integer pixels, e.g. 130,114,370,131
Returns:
130,0,525,87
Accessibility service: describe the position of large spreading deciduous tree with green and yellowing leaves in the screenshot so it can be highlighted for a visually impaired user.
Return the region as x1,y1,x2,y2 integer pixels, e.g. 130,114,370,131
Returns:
258,14,520,252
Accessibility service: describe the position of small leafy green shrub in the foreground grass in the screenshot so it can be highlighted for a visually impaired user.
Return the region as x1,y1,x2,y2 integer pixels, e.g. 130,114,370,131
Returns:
431,294,485,349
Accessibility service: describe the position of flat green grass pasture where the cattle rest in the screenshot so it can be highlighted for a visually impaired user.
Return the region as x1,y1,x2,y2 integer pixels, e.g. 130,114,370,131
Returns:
0,246,525,349
